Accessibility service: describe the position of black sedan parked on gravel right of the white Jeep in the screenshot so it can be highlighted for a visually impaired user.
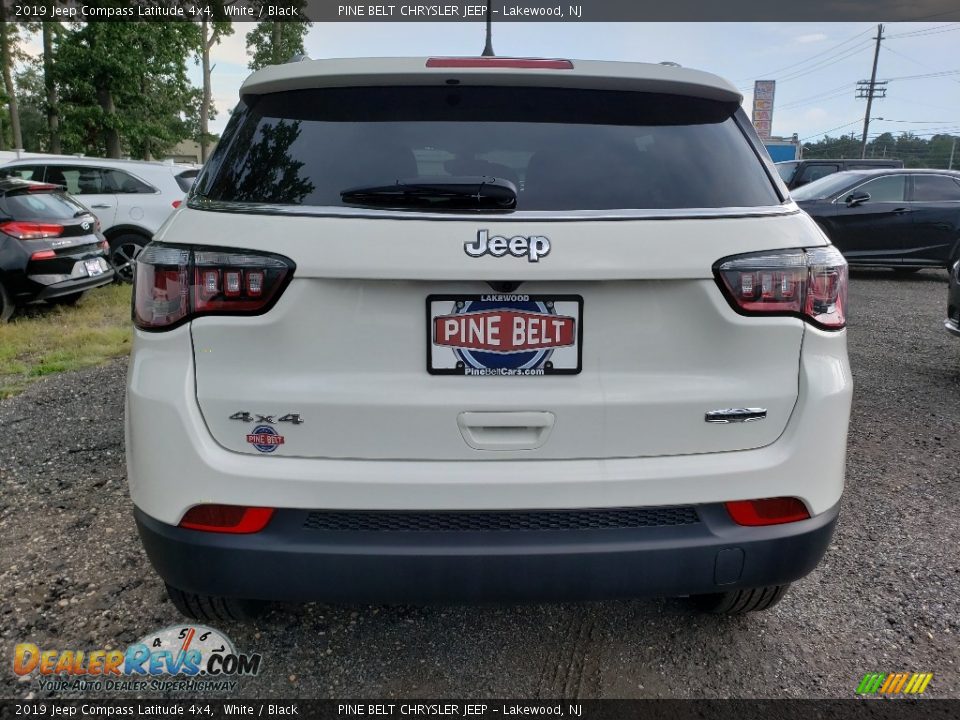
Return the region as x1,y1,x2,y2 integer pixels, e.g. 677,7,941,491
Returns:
792,168,960,272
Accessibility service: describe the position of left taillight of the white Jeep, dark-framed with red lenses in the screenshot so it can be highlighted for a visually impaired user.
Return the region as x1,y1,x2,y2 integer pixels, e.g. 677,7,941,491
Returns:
133,243,295,330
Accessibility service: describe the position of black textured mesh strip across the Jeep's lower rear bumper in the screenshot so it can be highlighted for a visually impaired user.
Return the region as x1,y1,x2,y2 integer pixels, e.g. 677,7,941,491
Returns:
303,505,700,532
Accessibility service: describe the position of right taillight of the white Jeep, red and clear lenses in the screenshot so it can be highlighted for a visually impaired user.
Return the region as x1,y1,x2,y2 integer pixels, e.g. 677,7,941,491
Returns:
713,245,848,330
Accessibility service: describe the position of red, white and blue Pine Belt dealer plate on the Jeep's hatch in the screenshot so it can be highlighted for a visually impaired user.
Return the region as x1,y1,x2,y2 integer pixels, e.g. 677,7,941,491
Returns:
427,293,583,377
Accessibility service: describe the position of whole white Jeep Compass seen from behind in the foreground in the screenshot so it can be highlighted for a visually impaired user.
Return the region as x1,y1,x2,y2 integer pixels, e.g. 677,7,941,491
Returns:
126,57,852,620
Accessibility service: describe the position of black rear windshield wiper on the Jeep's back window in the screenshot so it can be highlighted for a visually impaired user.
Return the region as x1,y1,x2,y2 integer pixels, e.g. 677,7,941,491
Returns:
340,176,517,210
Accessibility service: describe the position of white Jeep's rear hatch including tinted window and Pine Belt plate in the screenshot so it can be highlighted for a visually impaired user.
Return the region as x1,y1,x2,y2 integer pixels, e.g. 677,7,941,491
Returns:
176,66,816,460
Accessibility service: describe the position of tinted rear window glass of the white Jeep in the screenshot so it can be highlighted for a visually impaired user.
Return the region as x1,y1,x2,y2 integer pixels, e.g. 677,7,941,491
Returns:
196,87,780,210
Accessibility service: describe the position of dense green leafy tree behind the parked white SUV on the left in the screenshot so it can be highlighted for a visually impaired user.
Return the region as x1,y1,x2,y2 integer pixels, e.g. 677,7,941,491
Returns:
54,22,201,158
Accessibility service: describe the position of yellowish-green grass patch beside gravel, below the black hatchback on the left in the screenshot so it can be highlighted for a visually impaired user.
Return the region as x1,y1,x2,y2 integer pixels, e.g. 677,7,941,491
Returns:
0,285,132,398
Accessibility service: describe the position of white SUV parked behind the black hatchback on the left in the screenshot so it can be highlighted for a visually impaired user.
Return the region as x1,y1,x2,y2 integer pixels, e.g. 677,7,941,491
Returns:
0,155,199,279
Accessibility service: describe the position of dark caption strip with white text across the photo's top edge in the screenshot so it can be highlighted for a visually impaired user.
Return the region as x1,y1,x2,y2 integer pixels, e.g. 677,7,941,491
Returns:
0,0,960,23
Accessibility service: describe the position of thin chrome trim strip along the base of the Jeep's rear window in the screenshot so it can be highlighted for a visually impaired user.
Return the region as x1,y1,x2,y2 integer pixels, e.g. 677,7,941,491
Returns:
187,197,800,222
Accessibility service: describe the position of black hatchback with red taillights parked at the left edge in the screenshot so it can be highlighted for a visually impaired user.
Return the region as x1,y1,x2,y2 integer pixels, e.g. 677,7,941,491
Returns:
0,178,113,322
